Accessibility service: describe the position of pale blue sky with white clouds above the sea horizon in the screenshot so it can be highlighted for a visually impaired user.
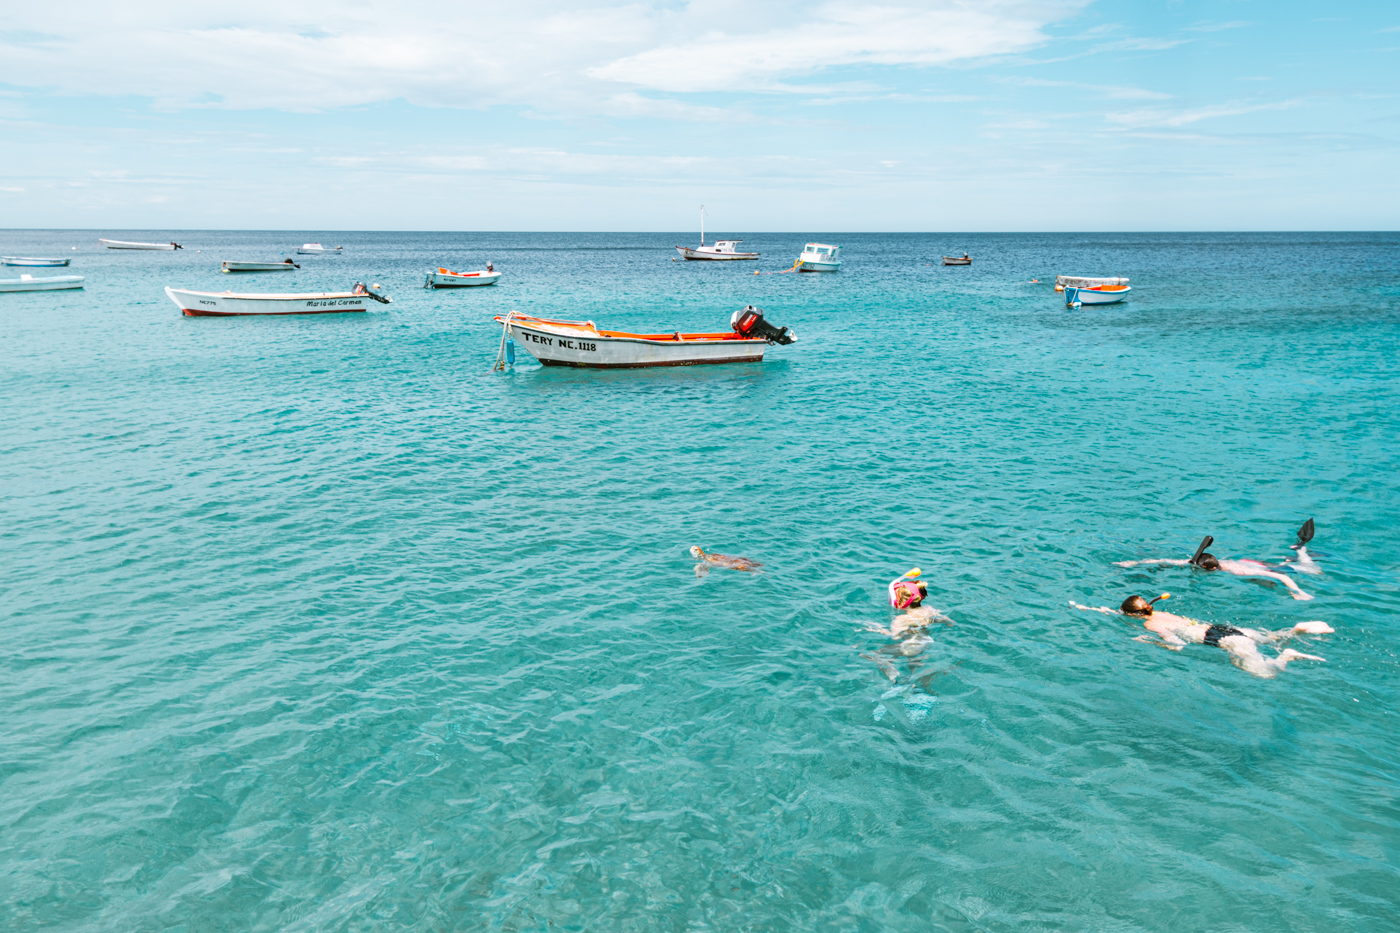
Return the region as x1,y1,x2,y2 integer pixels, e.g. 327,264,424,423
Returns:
0,0,1400,233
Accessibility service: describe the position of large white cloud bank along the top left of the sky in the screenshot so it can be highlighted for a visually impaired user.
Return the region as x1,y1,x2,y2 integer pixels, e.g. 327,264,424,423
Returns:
0,0,1082,115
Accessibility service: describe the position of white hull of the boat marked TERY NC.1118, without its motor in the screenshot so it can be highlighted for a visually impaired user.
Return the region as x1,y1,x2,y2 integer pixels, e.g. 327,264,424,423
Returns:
505,318,769,370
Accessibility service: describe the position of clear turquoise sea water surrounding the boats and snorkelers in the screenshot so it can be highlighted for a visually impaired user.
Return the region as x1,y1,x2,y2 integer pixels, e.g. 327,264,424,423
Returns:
0,231,1400,932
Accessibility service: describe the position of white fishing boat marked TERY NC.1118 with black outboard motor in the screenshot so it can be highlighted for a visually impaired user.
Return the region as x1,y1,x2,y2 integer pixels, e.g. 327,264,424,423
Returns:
496,304,797,370
